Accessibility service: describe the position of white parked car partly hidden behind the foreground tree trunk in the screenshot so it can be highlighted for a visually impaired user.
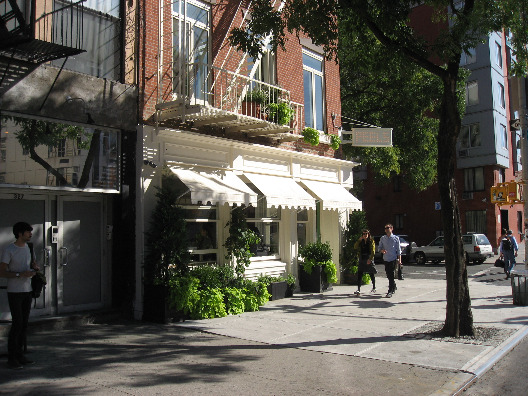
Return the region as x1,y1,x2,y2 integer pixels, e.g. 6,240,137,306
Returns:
411,234,493,264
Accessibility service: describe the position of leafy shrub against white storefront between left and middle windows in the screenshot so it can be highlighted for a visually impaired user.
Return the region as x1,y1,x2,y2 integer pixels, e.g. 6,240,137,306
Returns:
224,206,260,277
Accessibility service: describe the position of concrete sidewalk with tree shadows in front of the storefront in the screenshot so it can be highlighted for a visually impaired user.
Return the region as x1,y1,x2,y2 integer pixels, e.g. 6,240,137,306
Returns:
0,258,528,395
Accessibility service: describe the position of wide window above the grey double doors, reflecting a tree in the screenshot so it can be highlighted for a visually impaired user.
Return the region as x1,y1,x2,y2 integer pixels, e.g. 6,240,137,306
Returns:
0,116,120,191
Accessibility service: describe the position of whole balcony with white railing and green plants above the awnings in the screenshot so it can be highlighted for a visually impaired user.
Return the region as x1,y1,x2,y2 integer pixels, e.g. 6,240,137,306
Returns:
155,63,304,142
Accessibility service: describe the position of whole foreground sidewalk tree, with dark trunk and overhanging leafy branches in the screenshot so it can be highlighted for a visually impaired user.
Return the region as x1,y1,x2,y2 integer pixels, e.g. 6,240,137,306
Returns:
230,0,528,336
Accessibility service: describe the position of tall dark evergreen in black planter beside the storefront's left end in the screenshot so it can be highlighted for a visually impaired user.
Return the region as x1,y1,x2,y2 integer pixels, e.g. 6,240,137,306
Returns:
143,186,190,323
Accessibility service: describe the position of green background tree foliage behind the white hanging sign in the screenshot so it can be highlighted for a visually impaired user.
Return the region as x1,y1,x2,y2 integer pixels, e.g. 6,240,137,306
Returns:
339,24,442,190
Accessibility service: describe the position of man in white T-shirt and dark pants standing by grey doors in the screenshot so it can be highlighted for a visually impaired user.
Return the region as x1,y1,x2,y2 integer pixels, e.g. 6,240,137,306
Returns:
0,222,39,370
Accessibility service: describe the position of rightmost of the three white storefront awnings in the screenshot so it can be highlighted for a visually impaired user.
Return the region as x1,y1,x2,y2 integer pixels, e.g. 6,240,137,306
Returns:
302,180,363,210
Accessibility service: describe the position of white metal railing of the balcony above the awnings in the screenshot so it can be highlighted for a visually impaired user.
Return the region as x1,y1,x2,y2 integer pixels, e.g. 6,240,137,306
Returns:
172,63,304,134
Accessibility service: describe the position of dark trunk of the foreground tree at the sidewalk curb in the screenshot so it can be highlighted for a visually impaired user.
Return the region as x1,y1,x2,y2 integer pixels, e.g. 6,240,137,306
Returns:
438,64,474,337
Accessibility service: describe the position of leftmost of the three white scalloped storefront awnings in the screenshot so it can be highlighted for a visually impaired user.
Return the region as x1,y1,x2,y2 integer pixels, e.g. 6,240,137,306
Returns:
171,167,257,205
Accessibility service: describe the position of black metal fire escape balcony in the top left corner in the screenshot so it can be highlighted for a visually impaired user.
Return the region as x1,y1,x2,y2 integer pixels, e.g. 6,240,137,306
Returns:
0,0,85,64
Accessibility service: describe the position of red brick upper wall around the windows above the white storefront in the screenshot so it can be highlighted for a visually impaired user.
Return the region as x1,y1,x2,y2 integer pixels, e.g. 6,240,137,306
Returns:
140,0,341,156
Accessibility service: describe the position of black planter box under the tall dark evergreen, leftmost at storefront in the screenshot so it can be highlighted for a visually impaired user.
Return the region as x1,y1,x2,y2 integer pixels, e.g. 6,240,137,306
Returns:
143,285,183,323
